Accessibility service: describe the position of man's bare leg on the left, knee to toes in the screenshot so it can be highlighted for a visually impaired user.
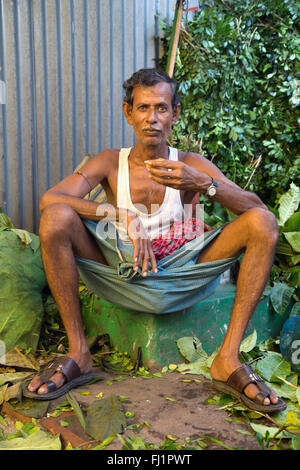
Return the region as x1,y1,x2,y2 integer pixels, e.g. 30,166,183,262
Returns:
28,204,107,393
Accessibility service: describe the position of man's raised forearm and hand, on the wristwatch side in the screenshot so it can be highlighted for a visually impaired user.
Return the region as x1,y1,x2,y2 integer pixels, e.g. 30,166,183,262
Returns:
147,153,267,215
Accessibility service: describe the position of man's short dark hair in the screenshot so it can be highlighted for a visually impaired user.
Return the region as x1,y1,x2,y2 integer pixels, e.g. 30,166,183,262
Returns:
123,69,180,109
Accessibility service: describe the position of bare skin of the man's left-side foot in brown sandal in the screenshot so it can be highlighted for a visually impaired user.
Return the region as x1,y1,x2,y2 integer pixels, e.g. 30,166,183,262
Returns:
27,351,92,395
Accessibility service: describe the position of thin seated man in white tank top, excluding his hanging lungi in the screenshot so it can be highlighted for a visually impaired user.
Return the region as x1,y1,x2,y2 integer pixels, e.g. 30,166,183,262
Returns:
26,69,285,412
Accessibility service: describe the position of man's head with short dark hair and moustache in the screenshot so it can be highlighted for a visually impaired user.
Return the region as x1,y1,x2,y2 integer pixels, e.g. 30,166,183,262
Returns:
123,69,180,147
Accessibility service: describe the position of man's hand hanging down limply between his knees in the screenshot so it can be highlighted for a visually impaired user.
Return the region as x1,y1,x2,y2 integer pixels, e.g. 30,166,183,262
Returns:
123,211,157,277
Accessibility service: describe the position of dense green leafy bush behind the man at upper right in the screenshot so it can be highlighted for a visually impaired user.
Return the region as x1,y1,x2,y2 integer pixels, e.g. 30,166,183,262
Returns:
160,0,300,206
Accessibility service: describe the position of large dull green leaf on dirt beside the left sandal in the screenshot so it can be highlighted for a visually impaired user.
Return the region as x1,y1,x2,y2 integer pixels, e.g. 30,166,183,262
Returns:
86,395,126,441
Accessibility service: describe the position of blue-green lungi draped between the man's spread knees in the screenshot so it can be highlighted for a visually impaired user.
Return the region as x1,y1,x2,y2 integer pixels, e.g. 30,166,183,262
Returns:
76,220,238,314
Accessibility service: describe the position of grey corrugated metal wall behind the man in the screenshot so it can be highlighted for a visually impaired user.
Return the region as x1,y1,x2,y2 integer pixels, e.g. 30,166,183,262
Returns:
0,0,199,232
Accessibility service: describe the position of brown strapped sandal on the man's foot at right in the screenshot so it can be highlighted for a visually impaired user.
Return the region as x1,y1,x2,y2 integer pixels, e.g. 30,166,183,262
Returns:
212,364,286,413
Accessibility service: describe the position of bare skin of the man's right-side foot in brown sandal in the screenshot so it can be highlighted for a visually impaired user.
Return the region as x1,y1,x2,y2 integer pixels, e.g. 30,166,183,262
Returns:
210,354,278,405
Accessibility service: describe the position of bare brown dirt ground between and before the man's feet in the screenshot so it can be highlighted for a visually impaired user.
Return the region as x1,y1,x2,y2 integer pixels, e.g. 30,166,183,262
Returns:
14,371,260,450
